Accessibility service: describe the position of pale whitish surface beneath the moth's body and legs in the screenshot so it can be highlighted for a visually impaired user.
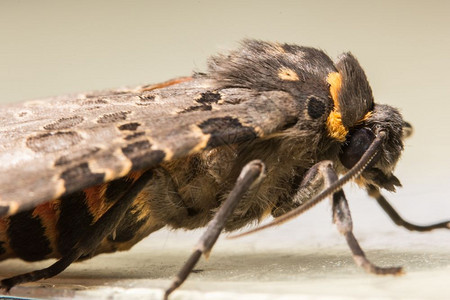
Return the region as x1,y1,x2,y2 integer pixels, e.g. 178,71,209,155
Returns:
0,191,450,299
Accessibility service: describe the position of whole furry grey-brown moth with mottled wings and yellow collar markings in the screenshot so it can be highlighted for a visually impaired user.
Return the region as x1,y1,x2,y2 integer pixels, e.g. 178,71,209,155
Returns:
0,40,450,298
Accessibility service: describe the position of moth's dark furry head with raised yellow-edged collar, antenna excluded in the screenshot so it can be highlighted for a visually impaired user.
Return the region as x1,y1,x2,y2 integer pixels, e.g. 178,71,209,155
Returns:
327,53,412,191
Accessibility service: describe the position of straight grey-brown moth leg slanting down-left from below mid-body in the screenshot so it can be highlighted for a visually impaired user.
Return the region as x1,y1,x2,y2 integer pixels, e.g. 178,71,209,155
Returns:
164,160,265,299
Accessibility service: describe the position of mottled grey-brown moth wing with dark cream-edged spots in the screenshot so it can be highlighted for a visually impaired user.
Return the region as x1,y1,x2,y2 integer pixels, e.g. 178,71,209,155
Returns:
0,78,295,216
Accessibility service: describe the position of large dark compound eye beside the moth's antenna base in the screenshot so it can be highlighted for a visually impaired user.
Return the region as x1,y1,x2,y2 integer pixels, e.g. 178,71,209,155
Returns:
339,128,375,169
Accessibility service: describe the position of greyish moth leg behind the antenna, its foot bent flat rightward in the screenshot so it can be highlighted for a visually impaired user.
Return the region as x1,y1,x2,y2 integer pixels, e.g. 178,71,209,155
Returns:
323,163,402,275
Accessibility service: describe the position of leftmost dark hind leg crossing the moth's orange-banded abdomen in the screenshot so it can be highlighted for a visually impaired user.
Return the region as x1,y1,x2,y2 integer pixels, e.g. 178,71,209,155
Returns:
0,170,153,291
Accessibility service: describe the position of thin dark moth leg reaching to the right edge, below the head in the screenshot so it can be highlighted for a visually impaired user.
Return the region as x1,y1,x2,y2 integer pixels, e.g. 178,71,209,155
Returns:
367,185,450,231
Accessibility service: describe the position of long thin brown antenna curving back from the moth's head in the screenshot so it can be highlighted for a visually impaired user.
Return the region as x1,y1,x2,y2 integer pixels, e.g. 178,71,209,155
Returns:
227,131,386,239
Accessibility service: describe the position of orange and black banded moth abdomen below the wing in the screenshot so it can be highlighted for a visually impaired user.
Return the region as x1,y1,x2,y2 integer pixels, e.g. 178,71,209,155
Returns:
0,173,160,261
